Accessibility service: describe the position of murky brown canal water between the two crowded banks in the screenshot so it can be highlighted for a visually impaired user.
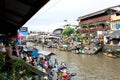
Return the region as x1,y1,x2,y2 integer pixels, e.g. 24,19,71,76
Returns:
33,46,120,80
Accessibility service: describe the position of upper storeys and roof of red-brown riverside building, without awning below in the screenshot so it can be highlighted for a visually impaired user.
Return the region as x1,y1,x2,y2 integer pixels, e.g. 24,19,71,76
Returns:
77,5,120,33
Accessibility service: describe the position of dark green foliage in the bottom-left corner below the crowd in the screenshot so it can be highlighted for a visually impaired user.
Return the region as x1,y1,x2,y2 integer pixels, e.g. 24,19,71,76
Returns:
0,55,32,80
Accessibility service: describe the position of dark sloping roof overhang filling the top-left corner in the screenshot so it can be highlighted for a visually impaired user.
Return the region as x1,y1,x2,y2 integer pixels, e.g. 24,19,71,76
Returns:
0,0,49,34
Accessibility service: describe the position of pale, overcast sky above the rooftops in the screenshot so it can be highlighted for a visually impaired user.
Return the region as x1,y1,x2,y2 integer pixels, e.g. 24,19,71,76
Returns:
23,0,120,32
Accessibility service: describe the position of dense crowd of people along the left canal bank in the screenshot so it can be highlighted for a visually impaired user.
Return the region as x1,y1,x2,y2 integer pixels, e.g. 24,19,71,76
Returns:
1,43,73,80
